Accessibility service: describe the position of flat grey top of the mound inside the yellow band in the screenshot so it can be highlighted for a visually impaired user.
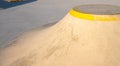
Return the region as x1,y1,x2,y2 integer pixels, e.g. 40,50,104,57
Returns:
73,4,120,15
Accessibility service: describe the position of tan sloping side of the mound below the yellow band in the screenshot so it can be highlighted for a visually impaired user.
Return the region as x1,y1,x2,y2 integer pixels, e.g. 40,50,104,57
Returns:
0,4,120,66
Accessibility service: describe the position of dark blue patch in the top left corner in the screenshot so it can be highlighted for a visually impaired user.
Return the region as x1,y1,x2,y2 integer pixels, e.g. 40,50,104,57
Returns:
0,0,37,9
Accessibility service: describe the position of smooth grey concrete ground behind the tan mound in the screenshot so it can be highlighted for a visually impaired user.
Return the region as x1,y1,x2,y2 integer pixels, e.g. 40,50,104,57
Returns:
0,0,120,48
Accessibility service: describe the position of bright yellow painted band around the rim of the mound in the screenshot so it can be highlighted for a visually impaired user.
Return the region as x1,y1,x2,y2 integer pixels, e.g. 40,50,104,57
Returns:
69,9,120,21
